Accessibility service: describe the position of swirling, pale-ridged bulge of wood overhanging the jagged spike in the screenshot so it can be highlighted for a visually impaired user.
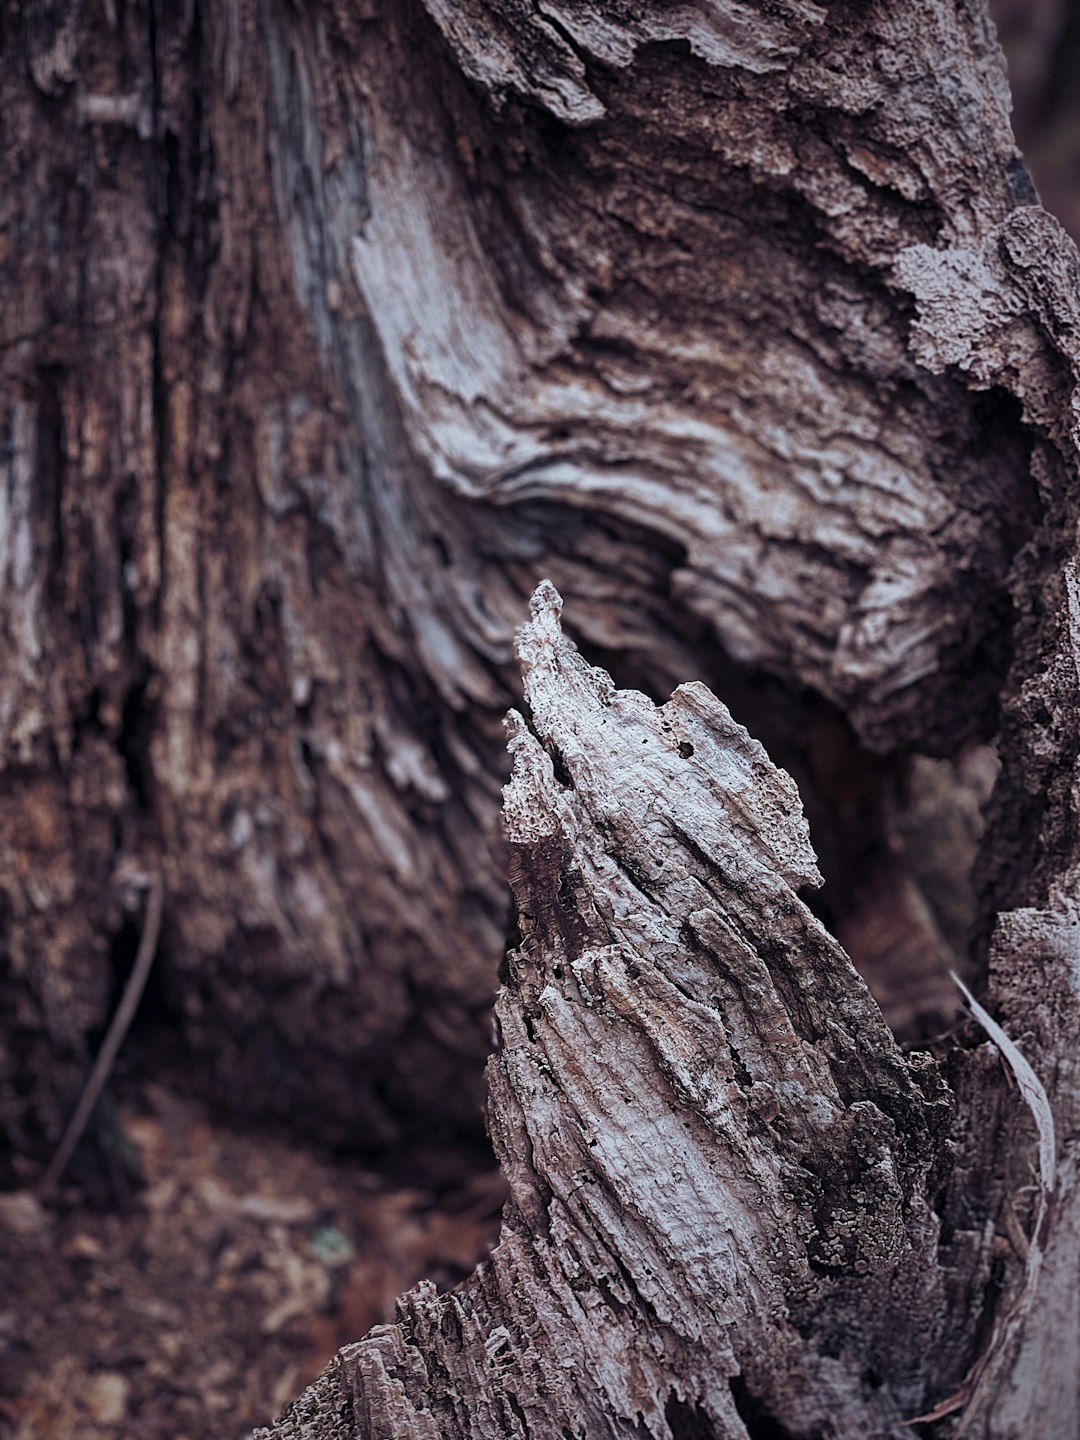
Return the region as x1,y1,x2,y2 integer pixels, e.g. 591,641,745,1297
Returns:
351,0,1030,747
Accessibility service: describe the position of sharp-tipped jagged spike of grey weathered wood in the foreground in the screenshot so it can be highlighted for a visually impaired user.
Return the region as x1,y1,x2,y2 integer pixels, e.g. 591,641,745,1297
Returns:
265,585,971,1440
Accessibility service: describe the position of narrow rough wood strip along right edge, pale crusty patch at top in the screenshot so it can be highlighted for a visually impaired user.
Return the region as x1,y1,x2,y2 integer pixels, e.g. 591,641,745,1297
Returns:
903,209,1080,1440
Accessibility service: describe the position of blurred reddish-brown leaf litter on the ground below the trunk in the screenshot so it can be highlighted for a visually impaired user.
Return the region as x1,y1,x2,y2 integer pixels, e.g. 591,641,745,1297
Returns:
0,1084,501,1440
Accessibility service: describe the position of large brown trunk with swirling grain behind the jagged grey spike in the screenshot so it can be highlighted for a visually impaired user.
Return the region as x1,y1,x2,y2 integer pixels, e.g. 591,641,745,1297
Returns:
0,0,1043,1156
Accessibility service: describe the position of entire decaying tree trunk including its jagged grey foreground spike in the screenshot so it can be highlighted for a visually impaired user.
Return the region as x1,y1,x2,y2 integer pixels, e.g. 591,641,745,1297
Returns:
0,0,1080,1437
